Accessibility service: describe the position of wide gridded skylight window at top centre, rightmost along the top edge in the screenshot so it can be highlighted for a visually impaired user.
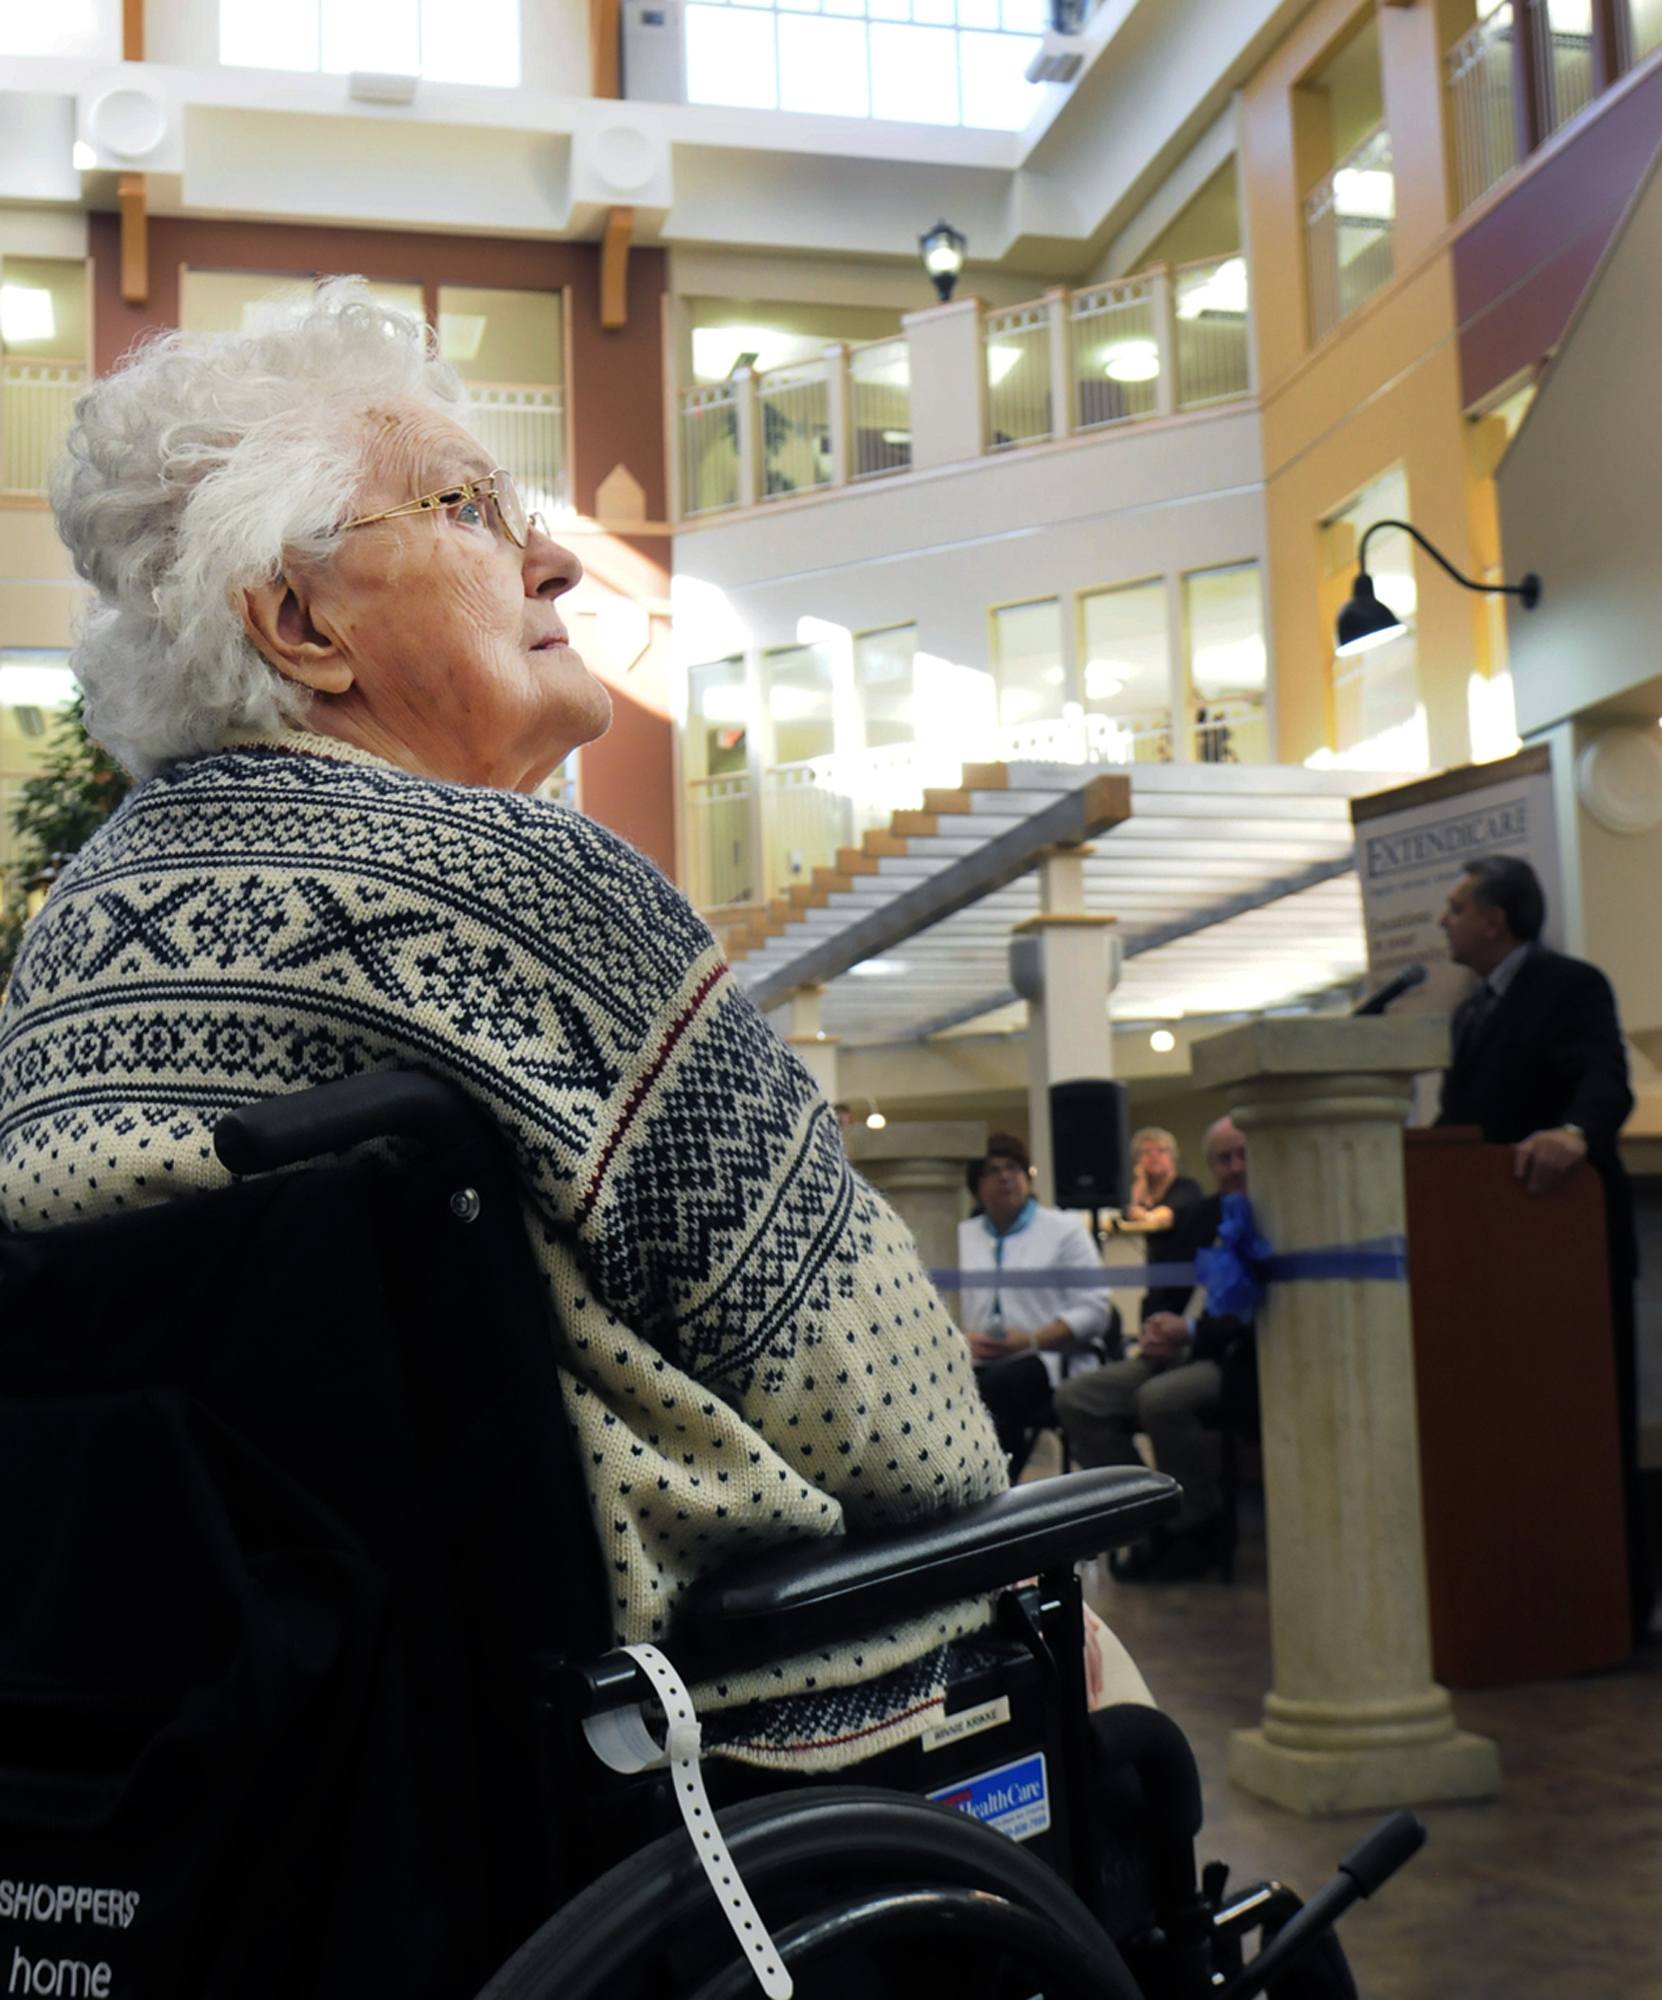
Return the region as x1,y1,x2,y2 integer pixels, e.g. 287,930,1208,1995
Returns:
686,0,1044,132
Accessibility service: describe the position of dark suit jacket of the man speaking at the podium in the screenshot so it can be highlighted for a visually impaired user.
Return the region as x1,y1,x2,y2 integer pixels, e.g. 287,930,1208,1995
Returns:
1438,944,1634,1276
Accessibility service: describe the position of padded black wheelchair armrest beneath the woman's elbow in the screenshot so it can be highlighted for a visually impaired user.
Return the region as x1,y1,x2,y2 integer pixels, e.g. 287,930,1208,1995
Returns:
674,1466,1180,1678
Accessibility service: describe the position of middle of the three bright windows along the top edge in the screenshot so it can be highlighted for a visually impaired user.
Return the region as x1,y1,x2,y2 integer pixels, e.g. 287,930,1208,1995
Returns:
220,0,520,88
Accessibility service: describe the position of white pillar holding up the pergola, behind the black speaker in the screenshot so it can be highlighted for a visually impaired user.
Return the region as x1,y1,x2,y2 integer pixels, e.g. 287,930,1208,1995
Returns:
1010,846,1118,1202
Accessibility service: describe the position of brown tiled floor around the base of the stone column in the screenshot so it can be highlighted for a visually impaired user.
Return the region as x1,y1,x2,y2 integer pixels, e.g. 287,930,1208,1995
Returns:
1088,1524,1662,2000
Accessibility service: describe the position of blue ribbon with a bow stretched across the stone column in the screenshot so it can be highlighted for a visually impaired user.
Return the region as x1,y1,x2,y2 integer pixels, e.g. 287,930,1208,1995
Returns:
930,1194,1408,1320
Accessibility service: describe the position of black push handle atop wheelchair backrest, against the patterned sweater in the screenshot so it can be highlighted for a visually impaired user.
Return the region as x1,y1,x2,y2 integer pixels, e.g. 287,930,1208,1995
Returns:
214,1070,480,1174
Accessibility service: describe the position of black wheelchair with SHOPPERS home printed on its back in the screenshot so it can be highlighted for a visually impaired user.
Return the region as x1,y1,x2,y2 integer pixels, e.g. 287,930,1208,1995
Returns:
0,1074,1424,2000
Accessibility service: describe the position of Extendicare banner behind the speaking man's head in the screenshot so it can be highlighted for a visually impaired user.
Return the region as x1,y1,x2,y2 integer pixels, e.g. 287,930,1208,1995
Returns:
1350,744,1564,1014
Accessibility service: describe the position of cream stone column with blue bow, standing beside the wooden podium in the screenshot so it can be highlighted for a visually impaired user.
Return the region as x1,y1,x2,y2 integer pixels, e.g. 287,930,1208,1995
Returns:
1194,1018,1500,1814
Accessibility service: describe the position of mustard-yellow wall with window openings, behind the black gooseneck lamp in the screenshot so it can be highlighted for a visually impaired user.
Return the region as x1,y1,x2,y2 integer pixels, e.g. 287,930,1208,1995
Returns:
1240,0,1498,766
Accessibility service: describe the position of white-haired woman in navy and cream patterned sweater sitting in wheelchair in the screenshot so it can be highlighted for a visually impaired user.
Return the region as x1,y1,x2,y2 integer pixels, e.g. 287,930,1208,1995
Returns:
0,282,1140,1768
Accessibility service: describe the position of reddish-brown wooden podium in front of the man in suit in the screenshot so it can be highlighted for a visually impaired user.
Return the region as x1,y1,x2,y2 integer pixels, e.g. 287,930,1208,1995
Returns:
1404,1126,1630,1688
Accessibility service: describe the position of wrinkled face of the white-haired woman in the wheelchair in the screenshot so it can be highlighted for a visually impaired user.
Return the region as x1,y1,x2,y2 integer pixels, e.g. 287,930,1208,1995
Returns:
298,402,612,790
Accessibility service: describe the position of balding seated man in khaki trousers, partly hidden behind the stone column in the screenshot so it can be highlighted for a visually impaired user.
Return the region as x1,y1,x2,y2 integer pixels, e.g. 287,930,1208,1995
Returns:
1056,1118,1258,1582
